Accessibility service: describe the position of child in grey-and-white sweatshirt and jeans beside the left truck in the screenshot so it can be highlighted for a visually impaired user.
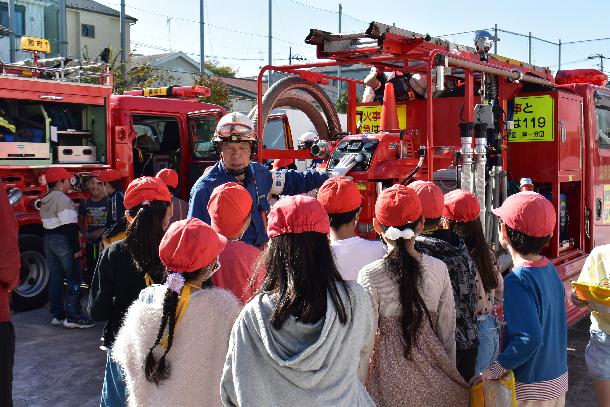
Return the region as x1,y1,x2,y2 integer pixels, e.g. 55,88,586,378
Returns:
40,167,95,328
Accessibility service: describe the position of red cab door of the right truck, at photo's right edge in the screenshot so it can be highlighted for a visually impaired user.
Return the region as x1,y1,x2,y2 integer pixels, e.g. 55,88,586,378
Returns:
589,91,610,247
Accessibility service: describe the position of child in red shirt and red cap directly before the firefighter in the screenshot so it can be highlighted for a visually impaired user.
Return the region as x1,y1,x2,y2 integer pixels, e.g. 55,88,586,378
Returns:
208,182,264,304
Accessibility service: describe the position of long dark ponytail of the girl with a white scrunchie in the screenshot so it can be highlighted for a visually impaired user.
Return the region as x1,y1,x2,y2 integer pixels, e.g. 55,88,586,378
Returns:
384,219,431,359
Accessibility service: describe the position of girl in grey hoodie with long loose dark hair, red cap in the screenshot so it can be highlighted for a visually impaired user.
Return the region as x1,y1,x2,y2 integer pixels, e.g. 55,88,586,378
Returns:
221,195,374,407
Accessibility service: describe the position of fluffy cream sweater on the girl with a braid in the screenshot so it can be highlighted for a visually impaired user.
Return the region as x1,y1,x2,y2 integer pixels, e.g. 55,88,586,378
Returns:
112,285,241,407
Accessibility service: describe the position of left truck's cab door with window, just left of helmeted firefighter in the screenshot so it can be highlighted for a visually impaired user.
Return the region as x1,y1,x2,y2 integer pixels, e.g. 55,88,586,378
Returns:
188,109,222,196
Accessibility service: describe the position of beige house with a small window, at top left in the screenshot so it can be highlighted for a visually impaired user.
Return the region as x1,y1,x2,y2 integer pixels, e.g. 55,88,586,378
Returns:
66,0,137,59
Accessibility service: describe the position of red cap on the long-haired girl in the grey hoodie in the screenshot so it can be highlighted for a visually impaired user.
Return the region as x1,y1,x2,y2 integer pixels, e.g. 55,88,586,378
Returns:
267,195,330,237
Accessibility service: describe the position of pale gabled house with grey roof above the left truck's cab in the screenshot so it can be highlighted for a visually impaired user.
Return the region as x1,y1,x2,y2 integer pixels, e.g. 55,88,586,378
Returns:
127,51,210,86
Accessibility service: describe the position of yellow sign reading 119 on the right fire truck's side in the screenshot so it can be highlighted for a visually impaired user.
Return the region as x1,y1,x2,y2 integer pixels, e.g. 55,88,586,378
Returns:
508,95,555,143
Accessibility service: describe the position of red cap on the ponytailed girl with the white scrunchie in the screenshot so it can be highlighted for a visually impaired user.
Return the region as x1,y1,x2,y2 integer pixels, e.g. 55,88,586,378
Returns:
375,184,422,226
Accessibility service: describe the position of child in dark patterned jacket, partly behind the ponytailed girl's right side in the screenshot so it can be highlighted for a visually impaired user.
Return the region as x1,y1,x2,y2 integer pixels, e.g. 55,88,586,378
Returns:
408,181,479,381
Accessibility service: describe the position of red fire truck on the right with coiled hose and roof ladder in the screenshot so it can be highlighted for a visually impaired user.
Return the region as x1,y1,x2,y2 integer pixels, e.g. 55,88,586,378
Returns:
252,22,610,324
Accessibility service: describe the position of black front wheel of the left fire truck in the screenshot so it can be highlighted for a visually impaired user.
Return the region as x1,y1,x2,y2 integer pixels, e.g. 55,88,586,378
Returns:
11,235,49,311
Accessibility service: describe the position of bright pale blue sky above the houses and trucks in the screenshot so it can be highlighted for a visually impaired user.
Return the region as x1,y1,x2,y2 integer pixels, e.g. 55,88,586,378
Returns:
98,0,610,77
